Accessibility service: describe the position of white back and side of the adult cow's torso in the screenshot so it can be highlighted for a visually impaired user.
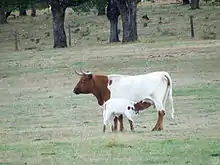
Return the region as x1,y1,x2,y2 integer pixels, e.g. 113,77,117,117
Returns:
108,71,167,101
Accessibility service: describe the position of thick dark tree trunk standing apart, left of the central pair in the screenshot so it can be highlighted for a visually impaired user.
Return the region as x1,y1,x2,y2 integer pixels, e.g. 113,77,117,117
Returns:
51,4,67,48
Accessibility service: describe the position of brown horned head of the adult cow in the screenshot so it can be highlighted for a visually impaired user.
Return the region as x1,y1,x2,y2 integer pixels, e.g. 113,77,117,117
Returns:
73,69,93,95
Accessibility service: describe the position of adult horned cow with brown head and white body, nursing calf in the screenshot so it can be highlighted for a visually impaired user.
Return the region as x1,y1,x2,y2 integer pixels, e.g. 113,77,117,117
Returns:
73,71,174,131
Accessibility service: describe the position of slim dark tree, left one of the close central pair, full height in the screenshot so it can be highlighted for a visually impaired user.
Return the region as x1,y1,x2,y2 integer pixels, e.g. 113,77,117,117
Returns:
107,0,120,42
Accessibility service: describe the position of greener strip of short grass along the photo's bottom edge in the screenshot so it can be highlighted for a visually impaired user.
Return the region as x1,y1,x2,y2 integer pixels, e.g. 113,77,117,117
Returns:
1,135,220,165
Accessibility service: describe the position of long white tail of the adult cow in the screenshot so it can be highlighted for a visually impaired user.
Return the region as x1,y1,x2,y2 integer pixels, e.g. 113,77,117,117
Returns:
163,72,175,119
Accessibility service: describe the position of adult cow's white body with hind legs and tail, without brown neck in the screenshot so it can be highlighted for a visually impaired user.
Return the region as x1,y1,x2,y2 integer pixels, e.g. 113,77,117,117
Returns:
108,71,174,130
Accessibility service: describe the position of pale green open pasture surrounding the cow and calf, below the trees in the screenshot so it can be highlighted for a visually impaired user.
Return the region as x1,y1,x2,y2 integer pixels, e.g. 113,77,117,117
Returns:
0,0,220,165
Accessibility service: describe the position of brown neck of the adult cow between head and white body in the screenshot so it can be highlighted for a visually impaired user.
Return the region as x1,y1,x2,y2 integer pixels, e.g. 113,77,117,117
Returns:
93,75,110,105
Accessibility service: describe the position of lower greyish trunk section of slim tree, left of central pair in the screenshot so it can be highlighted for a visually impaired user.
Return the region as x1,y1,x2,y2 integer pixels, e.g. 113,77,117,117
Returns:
109,19,119,42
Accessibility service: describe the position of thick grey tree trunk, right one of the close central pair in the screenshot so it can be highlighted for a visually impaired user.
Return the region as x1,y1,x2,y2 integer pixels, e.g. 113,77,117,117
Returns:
117,0,137,43
